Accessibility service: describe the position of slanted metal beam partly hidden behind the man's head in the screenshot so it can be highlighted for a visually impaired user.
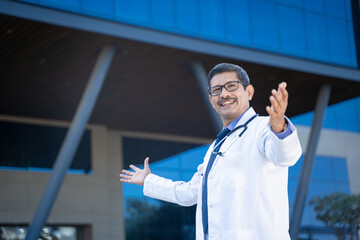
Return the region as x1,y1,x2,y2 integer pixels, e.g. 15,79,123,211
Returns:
191,62,224,132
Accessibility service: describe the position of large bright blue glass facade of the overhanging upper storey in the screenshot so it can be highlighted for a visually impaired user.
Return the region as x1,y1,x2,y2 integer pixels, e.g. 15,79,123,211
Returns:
13,0,358,68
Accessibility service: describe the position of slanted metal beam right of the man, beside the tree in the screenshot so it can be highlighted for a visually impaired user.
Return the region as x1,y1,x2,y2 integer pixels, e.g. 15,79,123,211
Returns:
290,84,331,240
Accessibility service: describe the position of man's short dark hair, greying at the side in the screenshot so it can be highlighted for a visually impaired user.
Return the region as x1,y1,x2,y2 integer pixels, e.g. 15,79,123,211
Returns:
208,63,250,89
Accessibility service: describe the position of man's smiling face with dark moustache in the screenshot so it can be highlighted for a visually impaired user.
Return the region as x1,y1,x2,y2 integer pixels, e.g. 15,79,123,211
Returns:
209,72,254,127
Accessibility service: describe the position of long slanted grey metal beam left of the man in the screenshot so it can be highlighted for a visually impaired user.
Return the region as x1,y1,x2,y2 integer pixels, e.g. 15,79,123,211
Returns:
26,46,115,240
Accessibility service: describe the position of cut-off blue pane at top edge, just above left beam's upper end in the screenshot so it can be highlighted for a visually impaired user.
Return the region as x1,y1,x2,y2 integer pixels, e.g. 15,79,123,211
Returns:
82,0,114,18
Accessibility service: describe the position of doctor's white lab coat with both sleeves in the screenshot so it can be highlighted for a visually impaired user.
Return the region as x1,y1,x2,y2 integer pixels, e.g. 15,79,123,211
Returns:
144,108,302,240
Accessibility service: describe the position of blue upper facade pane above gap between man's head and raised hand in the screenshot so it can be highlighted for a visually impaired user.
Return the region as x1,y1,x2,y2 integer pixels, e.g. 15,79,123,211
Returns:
251,0,279,50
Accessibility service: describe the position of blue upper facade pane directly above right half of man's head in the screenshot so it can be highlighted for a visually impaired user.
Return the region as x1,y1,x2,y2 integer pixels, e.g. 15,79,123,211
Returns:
225,0,251,45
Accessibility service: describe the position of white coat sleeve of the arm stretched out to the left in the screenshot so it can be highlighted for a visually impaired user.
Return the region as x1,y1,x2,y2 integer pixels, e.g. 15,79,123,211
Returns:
143,165,202,206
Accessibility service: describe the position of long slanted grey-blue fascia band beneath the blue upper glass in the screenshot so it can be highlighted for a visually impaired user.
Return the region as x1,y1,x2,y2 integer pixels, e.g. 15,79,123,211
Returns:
0,0,360,82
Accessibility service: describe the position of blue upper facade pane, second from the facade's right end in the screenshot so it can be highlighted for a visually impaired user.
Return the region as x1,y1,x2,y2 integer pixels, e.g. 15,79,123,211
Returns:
305,12,329,61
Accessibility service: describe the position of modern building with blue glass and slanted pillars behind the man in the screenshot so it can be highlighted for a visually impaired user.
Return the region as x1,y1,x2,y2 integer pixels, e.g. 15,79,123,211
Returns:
0,0,360,240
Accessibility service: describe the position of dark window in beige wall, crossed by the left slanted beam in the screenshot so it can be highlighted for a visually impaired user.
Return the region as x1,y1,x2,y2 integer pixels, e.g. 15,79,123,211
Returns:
0,122,91,173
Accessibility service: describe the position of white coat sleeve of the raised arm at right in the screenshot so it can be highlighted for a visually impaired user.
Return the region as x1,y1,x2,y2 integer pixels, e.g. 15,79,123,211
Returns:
261,116,302,167
